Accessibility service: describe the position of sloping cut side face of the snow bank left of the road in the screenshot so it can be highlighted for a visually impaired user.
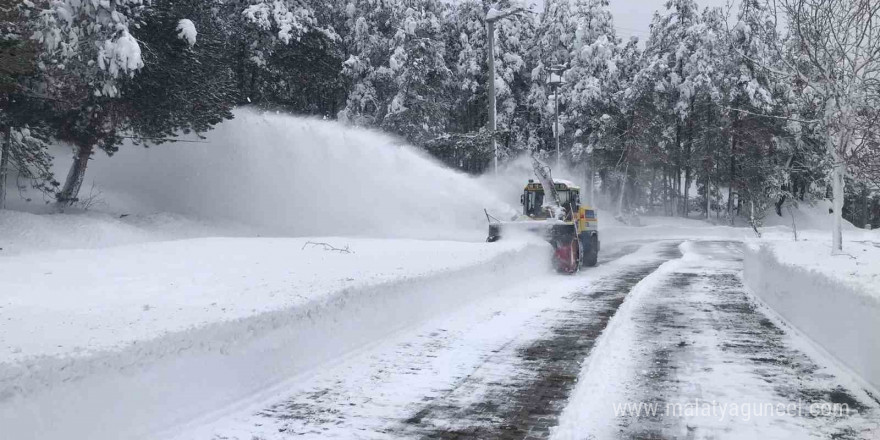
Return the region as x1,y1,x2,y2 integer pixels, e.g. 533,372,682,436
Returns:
0,246,549,440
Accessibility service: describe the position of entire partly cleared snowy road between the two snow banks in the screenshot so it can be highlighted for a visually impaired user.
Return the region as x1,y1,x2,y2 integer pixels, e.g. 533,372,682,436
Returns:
169,241,880,439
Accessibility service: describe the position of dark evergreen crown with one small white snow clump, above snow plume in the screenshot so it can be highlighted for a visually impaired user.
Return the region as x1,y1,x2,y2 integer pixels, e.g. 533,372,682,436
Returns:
117,0,237,143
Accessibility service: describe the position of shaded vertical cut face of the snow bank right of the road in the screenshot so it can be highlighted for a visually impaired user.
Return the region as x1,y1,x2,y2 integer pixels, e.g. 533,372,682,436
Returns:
745,244,880,390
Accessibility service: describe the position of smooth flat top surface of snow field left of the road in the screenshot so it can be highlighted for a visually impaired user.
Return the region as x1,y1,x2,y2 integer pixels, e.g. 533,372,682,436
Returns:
0,237,527,364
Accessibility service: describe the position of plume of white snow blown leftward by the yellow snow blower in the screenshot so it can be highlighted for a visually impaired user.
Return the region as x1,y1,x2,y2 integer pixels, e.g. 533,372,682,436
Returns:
72,109,518,240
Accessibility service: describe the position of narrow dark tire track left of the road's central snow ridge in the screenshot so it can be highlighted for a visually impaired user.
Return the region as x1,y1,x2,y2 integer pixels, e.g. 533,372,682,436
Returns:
401,243,681,439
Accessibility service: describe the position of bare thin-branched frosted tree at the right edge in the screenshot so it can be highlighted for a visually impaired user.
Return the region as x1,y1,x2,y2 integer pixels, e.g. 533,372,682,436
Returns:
740,0,880,248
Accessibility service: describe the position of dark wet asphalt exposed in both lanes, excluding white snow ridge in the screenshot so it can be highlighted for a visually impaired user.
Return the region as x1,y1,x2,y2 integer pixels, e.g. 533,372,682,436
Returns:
201,241,880,439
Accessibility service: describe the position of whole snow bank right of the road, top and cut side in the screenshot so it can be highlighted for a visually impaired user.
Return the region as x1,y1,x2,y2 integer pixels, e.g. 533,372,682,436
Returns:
744,239,880,390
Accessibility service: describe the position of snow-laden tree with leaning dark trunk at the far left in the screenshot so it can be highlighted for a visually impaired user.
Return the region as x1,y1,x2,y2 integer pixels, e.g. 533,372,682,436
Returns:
25,0,146,203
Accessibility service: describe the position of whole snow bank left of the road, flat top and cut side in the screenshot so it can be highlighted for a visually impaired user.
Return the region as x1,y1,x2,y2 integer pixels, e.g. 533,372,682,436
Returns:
0,238,547,439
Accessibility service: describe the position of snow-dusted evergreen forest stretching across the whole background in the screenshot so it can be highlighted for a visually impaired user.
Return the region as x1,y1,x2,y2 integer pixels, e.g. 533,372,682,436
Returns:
0,0,880,230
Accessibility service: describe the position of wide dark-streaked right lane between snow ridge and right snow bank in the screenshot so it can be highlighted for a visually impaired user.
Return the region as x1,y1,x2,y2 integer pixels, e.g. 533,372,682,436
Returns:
617,242,880,440
